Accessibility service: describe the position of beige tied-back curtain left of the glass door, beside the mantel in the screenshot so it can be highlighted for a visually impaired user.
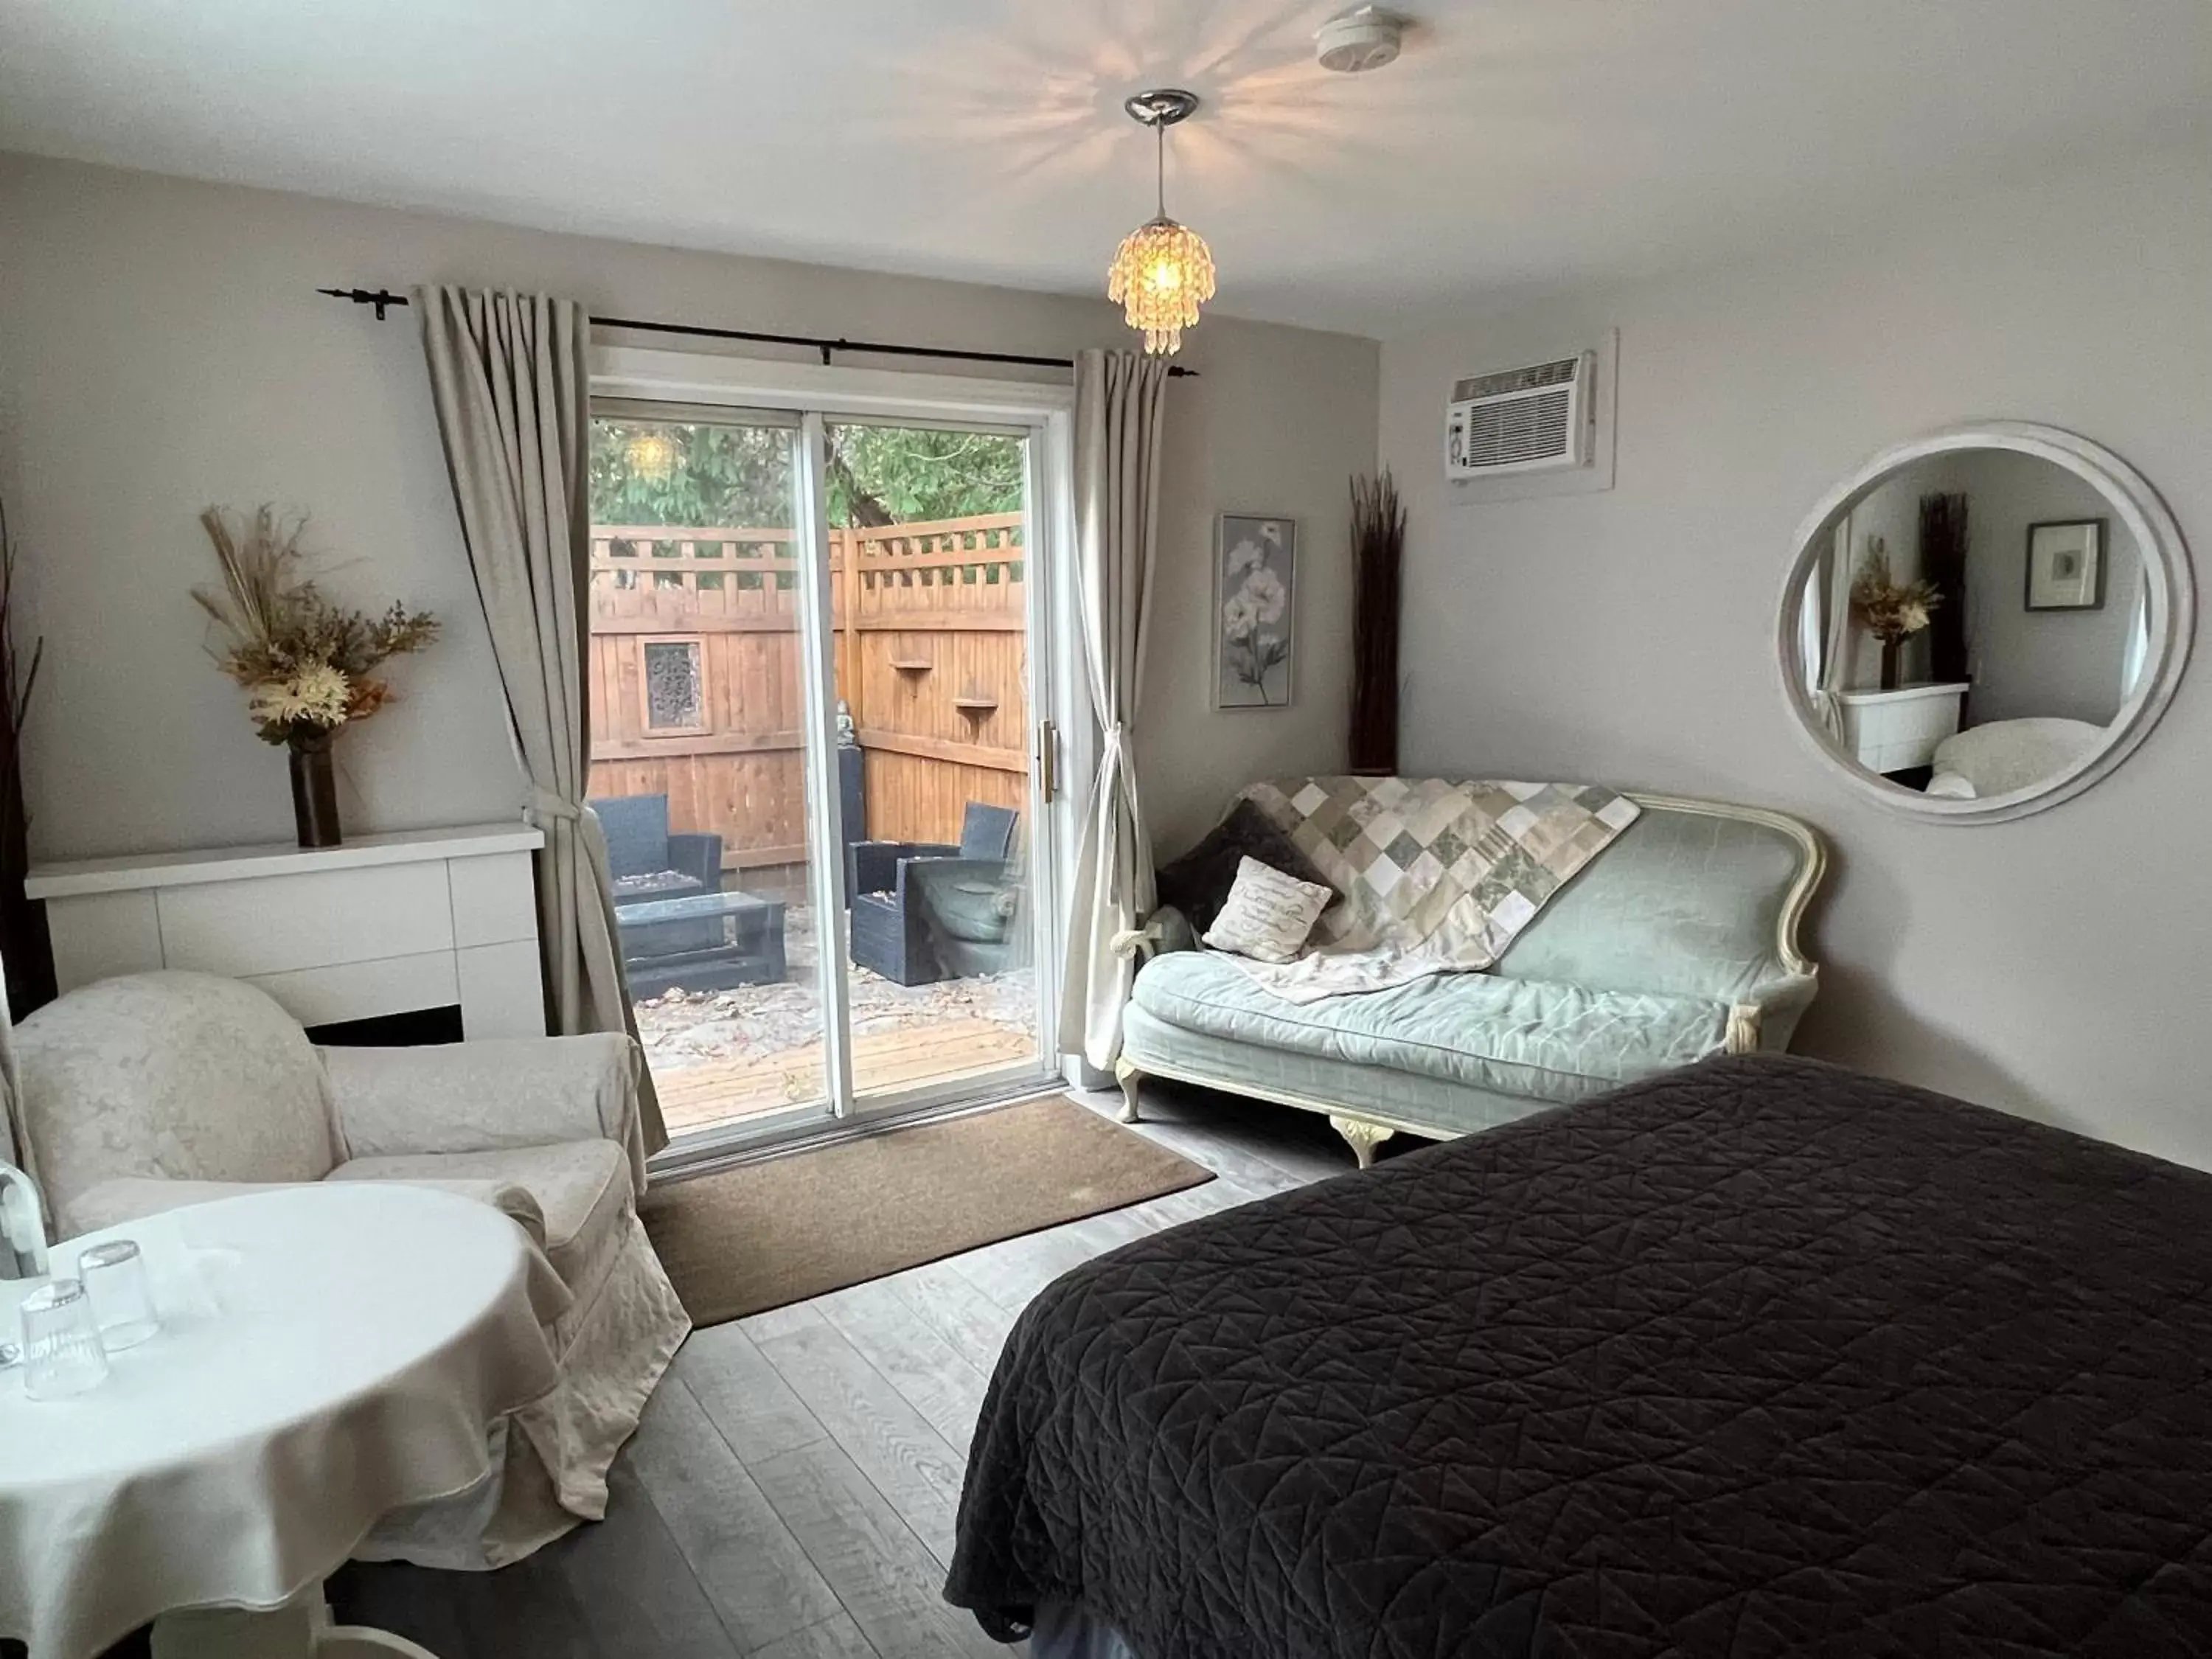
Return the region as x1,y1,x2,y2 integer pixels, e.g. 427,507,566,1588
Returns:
411,288,668,1152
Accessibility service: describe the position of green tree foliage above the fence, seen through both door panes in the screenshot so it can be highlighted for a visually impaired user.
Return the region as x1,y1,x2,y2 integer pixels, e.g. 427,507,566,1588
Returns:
591,420,1022,529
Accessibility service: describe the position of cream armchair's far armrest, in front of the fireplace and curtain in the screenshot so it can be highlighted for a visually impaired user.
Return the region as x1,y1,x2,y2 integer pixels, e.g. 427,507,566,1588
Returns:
321,1033,646,1192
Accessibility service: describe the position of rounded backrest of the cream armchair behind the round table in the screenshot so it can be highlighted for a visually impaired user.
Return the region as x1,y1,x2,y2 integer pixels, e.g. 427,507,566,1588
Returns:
15,973,338,1237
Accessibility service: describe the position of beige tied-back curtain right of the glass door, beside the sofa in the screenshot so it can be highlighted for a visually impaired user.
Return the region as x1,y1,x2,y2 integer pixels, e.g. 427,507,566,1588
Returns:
1060,352,1168,1071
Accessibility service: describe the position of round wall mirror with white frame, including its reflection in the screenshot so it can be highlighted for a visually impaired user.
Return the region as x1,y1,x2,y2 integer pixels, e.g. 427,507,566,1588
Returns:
1776,420,2197,823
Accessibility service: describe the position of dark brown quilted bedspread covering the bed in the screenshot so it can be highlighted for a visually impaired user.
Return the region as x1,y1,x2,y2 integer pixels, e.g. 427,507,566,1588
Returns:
947,1060,2212,1659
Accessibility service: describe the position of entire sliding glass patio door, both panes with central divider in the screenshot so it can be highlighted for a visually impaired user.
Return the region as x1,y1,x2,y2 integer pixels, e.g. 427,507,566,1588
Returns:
591,389,1053,1152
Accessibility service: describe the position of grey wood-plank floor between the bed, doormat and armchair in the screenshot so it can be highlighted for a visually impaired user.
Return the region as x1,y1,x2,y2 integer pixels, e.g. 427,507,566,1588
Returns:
330,1088,1396,1659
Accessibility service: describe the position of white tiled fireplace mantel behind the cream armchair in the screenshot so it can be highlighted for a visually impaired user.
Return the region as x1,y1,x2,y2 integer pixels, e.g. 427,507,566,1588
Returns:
24,823,546,1037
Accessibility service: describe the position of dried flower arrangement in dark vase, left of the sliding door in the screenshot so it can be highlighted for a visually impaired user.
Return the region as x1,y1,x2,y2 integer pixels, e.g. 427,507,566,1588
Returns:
192,507,438,847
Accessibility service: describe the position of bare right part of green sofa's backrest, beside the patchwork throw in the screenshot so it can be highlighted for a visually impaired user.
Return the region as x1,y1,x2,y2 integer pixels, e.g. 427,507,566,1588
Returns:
1493,796,1825,1002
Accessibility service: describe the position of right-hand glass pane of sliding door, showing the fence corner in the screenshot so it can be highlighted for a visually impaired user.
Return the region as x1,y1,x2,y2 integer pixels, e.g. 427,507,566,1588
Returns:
825,420,1042,1104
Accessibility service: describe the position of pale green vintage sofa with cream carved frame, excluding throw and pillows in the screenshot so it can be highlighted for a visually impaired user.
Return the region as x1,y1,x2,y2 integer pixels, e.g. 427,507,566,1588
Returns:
1115,794,1827,1168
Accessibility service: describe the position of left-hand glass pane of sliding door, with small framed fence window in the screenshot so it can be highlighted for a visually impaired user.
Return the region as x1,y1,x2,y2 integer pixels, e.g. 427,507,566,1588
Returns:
591,407,832,1137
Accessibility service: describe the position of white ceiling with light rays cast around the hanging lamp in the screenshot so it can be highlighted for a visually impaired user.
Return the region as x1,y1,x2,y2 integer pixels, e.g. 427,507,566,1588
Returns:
0,0,2212,334
